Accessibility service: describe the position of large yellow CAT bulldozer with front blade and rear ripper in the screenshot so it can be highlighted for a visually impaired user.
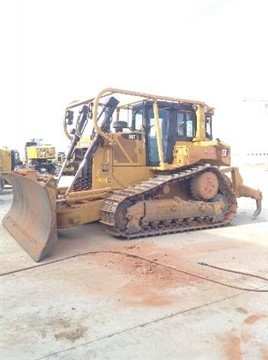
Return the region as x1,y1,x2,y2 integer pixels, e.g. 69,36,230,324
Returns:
3,88,262,261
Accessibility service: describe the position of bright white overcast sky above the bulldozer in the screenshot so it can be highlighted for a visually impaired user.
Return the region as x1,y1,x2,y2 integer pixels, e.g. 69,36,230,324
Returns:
0,0,268,158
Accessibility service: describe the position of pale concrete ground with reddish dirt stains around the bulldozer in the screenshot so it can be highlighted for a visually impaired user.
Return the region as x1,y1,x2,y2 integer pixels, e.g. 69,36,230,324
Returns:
0,165,268,360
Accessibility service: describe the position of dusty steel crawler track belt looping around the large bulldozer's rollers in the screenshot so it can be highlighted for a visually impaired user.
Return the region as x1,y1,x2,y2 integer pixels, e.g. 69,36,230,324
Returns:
100,165,237,239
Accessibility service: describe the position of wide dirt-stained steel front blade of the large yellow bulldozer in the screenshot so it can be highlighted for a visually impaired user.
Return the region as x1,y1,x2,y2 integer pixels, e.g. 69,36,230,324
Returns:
2,174,58,261
